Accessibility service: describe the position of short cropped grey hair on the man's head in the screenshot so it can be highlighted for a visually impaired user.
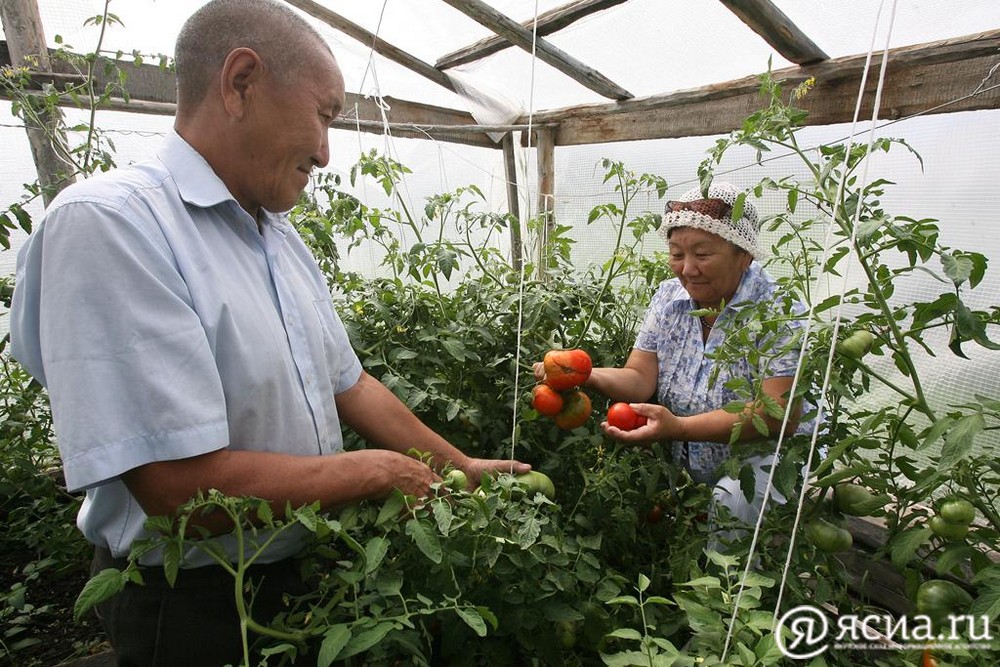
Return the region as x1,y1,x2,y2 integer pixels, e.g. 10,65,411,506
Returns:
174,0,330,107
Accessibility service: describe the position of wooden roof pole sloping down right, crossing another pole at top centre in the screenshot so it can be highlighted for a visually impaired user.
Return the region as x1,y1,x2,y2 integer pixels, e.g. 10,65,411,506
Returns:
436,0,632,100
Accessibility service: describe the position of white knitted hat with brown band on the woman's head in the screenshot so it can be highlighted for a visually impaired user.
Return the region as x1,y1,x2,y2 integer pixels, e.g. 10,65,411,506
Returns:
660,183,767,260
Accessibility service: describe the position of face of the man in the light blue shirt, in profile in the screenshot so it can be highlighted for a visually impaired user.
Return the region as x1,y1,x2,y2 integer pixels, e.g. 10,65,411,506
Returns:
237,48,344,212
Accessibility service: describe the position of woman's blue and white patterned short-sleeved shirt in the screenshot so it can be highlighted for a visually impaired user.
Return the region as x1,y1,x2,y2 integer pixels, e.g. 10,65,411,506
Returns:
635,262,799,482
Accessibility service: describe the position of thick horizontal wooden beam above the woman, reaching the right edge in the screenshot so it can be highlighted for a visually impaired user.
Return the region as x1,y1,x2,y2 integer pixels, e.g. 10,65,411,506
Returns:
517,30,1000,146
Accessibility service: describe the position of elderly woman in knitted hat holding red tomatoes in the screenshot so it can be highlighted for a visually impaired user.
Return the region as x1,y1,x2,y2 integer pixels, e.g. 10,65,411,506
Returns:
536,183,799,536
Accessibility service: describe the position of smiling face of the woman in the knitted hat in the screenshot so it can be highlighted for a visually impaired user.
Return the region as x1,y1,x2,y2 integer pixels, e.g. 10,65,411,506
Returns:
669,227,753,308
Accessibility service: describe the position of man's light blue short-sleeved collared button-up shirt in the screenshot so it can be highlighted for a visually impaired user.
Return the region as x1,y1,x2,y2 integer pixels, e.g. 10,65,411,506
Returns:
11,133,361,560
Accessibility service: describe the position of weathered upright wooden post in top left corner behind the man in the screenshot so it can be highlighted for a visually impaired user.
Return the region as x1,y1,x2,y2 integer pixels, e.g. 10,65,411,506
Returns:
0,0,74,206
